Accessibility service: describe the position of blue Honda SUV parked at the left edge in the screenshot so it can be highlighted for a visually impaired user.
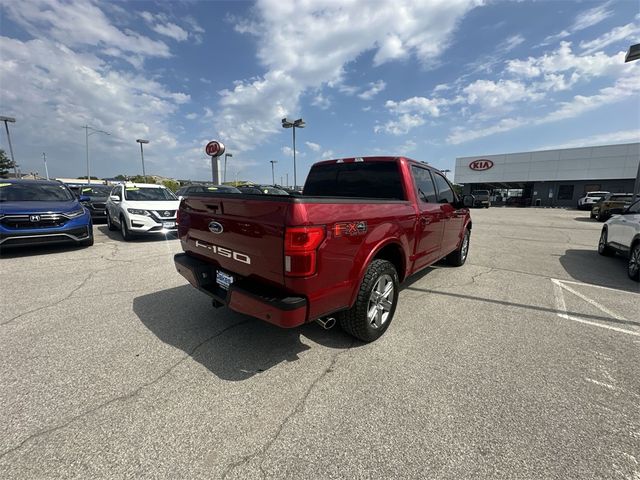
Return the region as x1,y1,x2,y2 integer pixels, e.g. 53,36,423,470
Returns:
0,179,93,249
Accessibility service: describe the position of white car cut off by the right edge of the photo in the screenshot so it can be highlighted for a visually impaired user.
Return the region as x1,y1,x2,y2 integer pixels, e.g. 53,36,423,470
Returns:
598,200,640,281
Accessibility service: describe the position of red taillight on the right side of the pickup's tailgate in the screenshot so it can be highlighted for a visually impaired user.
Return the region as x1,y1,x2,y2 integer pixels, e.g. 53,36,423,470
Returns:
284,227,325,277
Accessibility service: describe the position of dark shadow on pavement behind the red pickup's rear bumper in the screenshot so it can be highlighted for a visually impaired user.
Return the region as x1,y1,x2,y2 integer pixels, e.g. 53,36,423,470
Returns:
133,285,361,381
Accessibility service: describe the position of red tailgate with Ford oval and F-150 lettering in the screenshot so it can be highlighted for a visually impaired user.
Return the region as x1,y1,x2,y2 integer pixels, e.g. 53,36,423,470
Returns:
178,195,290,285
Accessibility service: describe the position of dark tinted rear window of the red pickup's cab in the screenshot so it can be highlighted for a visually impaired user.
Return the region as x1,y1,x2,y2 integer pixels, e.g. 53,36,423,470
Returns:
303,162,405,200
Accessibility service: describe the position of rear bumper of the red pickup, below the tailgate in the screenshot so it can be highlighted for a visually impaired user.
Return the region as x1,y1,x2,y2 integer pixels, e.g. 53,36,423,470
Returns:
174,253,307,328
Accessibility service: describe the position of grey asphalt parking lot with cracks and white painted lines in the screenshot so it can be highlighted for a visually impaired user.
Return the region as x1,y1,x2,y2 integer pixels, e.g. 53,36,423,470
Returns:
0,208,640,480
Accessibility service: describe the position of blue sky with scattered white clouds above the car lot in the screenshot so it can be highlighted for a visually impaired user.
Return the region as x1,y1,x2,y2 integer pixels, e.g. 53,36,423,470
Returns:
0,0,640,183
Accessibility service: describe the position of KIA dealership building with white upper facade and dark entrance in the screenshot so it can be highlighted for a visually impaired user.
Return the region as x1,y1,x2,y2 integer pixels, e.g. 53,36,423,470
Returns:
455,143,640,207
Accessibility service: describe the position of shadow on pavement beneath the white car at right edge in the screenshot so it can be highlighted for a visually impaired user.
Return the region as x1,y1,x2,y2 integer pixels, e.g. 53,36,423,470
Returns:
560,248,640,293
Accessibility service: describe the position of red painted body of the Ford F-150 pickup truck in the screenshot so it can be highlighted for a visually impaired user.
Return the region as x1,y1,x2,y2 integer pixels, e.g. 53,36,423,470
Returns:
176,157,471,327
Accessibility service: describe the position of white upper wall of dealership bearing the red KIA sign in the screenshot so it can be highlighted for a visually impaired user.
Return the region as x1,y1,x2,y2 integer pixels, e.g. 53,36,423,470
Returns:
454,143,640,184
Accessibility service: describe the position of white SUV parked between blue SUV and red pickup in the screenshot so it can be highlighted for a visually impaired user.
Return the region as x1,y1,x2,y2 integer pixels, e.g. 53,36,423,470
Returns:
106,183,180,240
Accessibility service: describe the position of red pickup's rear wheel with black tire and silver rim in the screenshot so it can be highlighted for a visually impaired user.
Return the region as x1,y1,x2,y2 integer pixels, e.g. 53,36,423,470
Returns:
338,260,400,342
